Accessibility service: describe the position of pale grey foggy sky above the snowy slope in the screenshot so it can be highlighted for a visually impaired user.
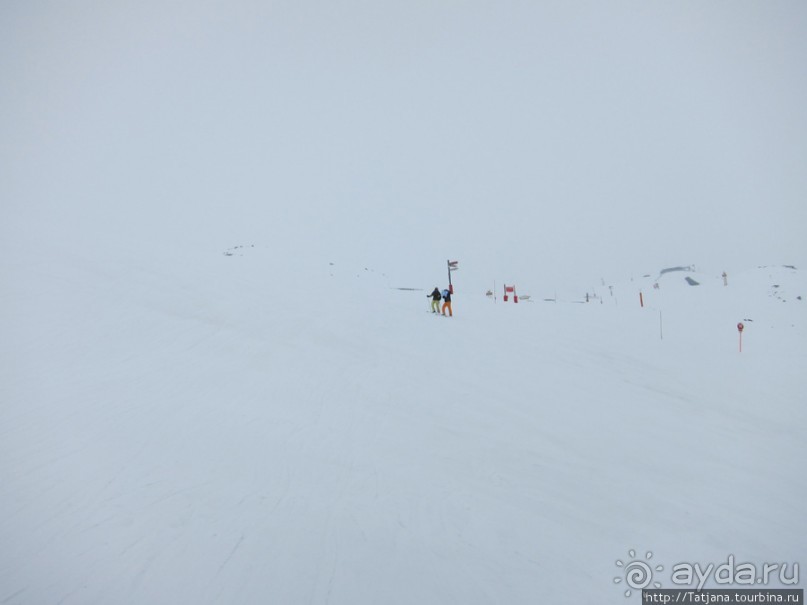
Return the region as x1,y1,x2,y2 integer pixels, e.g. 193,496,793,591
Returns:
0,0,807,286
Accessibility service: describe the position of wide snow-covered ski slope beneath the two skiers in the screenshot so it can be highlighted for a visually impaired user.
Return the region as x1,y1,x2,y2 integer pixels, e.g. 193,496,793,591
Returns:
0,230,807,605
